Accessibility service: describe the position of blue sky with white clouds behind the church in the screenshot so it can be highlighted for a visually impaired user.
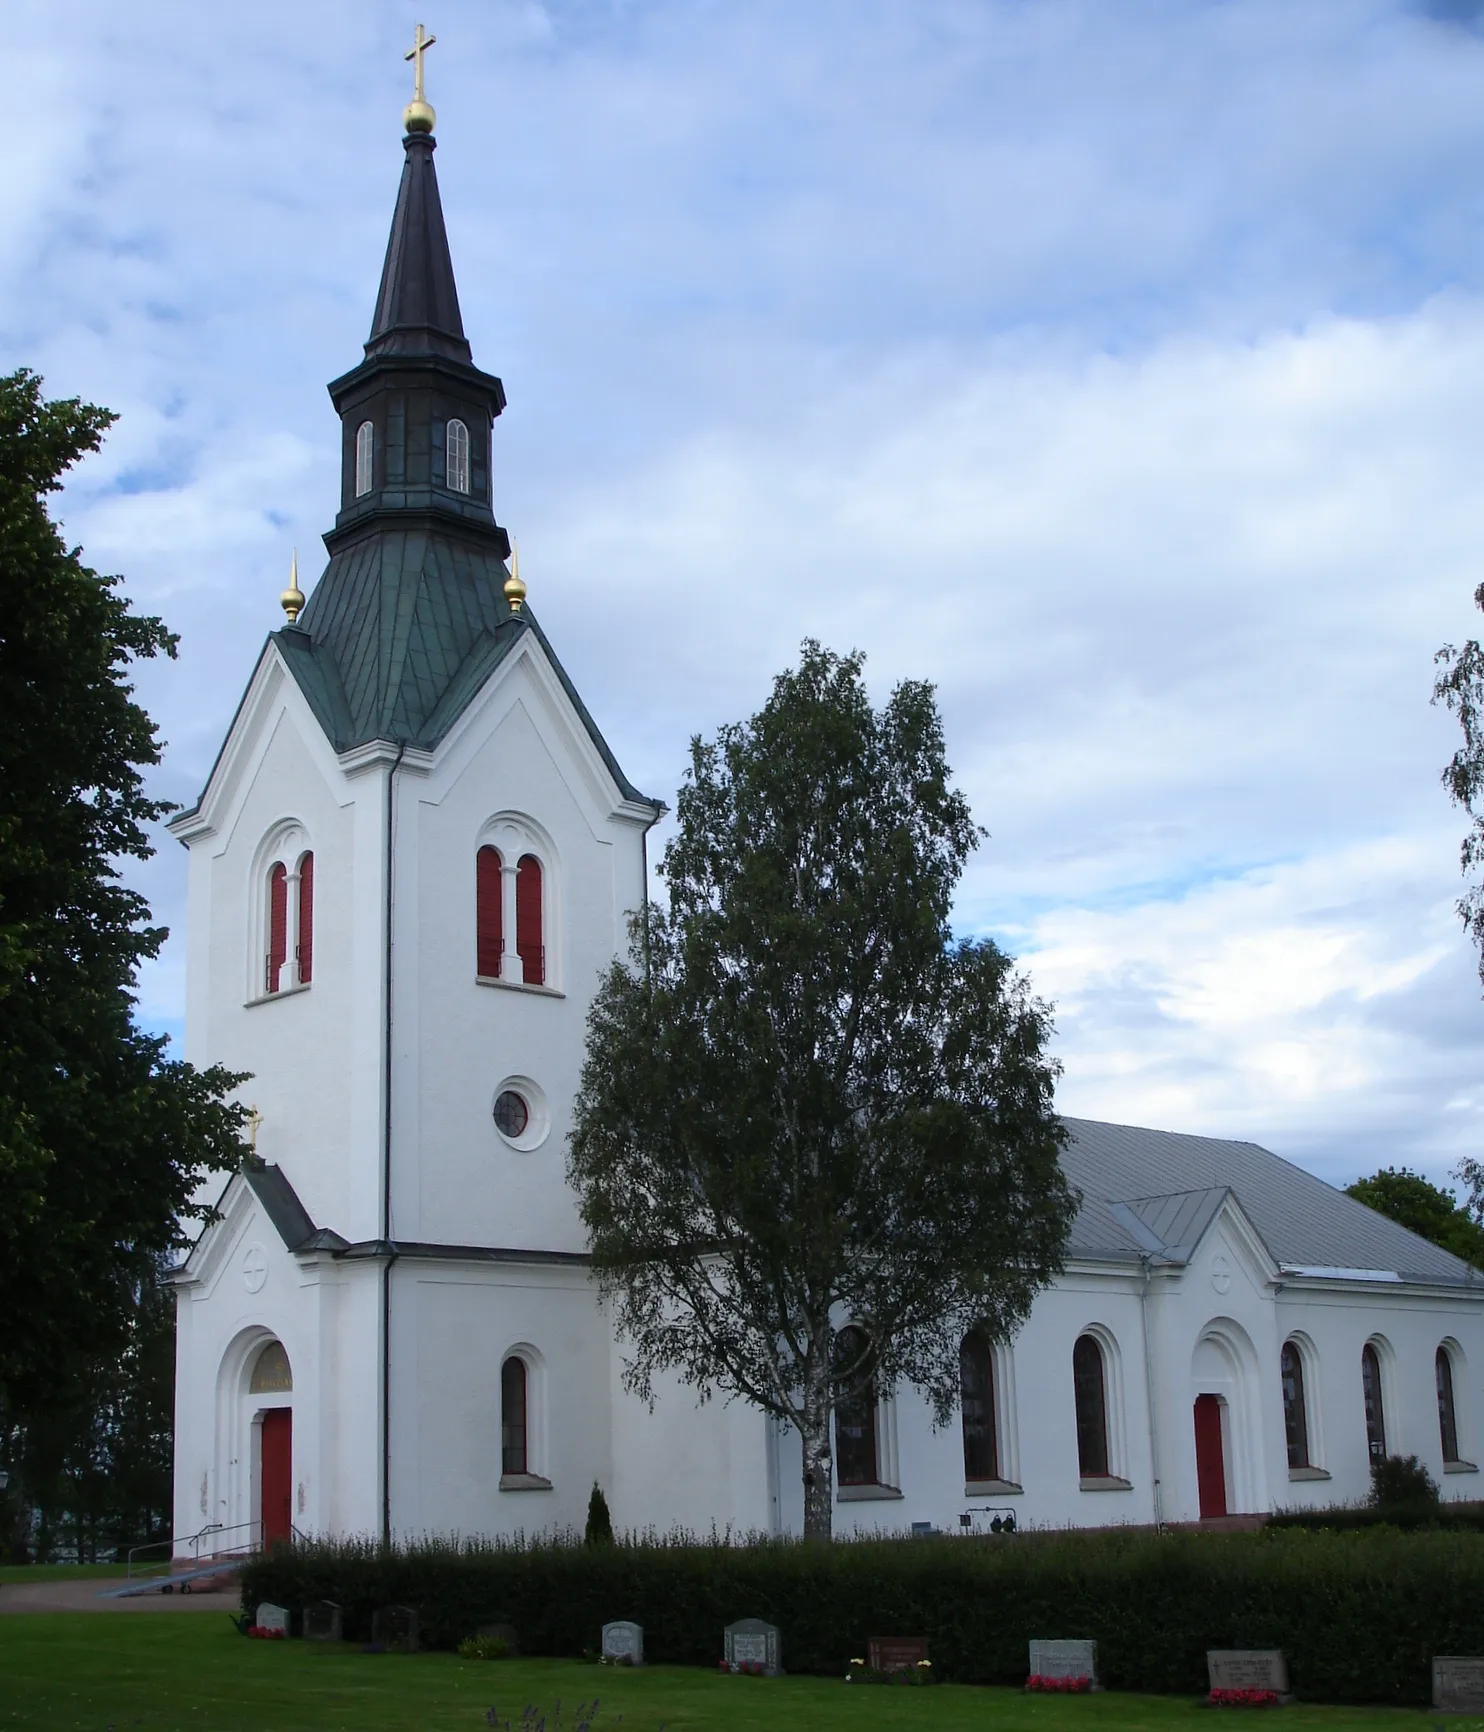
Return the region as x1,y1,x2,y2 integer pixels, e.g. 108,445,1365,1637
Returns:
0,0,1484,1183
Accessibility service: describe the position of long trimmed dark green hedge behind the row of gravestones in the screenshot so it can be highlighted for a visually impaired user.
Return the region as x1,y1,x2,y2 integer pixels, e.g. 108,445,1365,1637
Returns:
242,1528,1484,1703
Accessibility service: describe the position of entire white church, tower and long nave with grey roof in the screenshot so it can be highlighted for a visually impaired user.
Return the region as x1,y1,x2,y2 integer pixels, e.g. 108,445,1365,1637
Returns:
171,71,1484,1555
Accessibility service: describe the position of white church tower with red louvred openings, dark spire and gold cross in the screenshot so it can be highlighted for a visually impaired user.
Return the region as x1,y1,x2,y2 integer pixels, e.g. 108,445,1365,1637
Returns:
161,47,767,1552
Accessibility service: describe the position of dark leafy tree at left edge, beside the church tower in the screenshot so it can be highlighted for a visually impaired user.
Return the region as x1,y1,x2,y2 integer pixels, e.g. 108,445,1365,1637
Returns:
0,361,241,1531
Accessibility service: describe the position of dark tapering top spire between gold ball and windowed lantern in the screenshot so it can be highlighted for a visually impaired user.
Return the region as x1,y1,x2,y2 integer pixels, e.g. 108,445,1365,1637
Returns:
365,132,471,362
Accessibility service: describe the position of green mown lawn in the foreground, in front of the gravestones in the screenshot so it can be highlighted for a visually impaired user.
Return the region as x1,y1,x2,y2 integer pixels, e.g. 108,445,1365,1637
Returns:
0,1612,1461,1732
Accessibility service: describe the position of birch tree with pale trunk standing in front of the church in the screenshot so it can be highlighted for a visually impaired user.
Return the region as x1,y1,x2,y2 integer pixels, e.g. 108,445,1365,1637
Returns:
570,643,1077,1538
